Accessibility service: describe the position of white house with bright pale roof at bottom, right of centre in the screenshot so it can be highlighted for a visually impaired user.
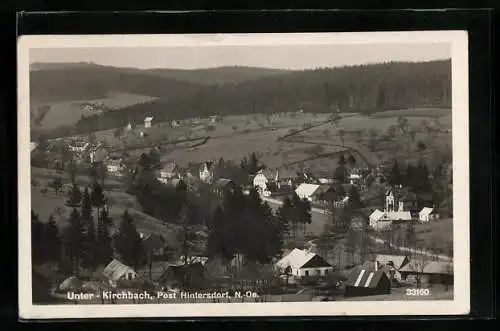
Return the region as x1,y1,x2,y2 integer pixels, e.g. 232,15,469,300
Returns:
275,248,333,279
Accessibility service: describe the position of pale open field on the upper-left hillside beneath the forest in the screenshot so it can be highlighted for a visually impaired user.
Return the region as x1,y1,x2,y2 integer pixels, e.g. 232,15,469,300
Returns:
38,93,155,130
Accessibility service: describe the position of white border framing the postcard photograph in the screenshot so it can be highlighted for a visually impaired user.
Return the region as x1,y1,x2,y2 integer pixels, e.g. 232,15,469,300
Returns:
18,31,470,319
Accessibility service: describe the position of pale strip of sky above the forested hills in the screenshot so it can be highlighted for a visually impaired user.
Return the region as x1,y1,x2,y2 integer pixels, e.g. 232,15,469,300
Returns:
29,43,451,70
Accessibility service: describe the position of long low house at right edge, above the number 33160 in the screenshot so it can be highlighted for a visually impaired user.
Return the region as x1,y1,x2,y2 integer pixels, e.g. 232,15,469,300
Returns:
399,260,453,285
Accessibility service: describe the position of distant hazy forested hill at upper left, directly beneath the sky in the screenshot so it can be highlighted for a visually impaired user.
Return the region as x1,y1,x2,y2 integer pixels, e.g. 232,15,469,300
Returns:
30,62,287,104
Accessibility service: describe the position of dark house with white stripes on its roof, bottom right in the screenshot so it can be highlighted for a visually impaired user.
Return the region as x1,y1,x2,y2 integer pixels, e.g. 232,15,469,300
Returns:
344,268,391,297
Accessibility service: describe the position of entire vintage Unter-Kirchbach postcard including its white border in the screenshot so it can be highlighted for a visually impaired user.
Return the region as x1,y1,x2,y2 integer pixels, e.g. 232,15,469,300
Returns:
18,31,470,319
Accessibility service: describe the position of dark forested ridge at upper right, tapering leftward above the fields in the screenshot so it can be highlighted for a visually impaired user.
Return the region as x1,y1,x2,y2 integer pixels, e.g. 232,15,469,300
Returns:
70,60,451,134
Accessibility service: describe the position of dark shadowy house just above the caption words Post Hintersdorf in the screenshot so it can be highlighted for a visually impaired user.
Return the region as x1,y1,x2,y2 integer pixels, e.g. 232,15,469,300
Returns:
158,263,207,289
